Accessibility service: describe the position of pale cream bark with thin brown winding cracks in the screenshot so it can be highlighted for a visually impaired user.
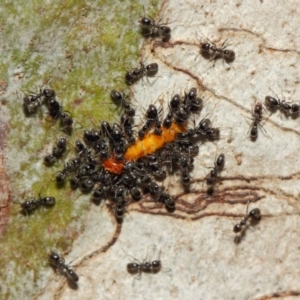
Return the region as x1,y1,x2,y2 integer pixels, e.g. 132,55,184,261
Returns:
1,0,300,300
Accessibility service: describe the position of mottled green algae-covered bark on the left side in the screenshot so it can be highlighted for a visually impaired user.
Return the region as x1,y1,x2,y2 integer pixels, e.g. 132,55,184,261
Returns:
0,0,158,299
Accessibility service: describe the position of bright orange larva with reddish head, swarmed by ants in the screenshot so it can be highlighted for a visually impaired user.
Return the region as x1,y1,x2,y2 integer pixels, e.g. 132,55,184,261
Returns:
102,122,186,174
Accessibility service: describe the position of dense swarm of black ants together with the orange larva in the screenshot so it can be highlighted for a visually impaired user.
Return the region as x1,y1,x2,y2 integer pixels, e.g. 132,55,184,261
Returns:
39,84,219,221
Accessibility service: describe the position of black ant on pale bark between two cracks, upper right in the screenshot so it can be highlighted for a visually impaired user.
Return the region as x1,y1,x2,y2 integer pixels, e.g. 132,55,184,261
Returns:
195,34,235,67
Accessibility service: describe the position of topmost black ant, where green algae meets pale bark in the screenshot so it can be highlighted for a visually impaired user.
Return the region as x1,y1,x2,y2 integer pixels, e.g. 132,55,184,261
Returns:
139,9,171,40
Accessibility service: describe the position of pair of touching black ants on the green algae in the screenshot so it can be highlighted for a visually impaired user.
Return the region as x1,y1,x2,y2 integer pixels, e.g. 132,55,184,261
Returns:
23,89,73,131
